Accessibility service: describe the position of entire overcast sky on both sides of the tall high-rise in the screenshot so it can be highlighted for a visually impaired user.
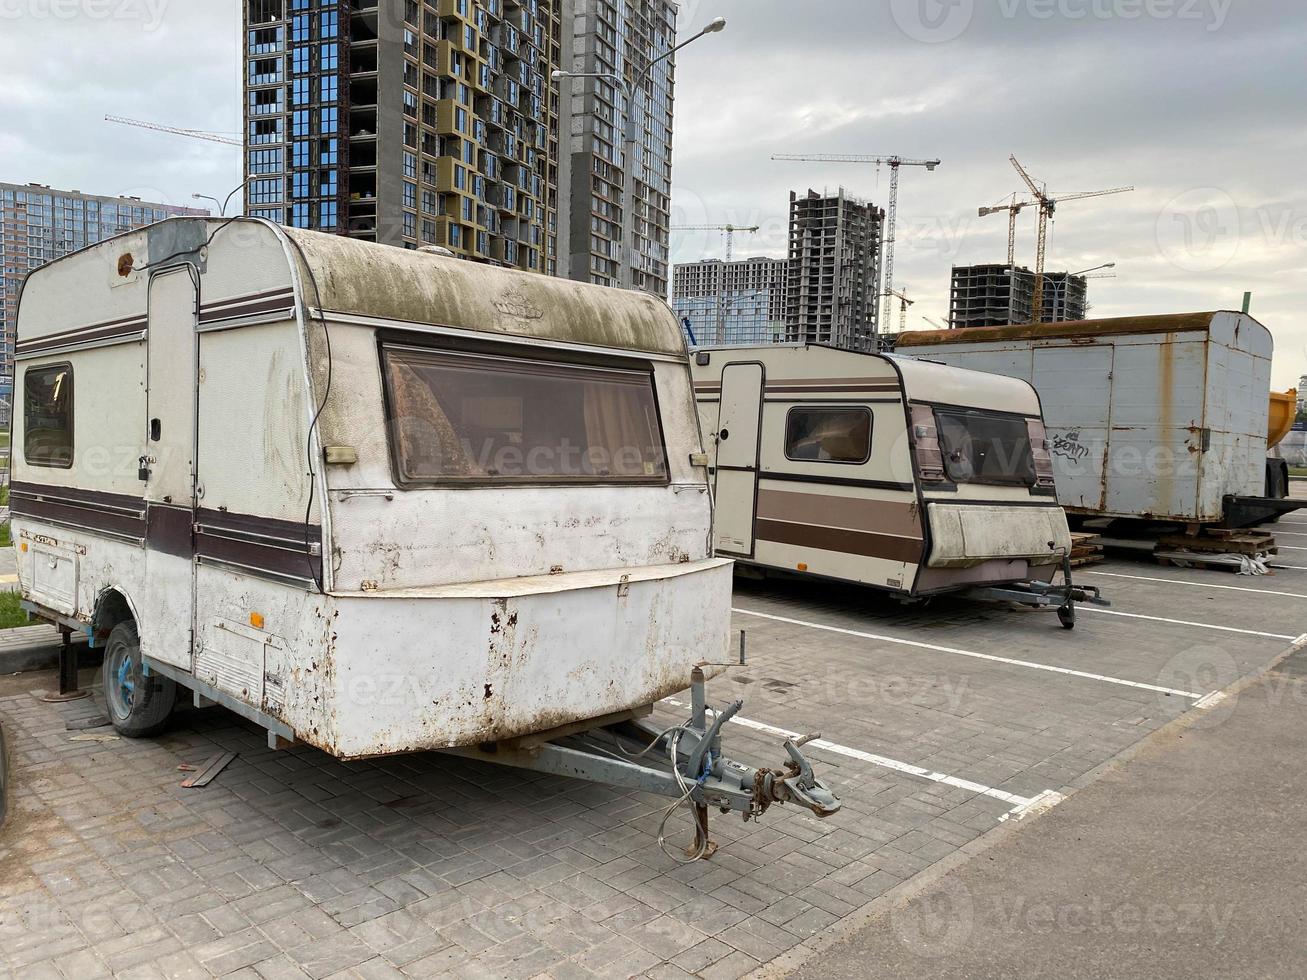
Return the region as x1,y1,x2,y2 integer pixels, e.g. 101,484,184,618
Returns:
0,0,1307,387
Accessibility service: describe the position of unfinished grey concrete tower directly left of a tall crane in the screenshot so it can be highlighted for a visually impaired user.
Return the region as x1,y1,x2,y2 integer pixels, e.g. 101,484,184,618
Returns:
786,188,885,350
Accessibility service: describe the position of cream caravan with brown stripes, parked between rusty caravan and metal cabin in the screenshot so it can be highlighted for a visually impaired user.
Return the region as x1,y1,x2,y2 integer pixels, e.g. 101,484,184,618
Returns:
694,344,1099,627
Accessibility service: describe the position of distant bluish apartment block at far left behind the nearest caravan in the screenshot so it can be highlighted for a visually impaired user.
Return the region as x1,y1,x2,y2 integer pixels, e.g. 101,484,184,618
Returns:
0,183,209,422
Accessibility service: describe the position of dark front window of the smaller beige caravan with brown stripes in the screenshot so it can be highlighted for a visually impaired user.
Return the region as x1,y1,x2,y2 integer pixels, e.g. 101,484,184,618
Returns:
935,409,1035,486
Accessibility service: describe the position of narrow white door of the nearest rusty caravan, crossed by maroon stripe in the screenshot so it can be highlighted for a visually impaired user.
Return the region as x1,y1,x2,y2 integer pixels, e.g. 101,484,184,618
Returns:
139,265,199,670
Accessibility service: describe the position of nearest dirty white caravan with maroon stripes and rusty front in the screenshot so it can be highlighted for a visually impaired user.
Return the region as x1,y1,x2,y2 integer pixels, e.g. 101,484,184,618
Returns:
12,218,838,846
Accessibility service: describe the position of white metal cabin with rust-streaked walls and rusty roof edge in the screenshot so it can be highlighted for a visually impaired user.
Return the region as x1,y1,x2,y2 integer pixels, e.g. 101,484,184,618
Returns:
897,312,1274,524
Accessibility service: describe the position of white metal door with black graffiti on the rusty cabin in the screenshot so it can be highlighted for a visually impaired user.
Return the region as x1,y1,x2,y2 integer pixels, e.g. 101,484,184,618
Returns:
1031,344,1115,511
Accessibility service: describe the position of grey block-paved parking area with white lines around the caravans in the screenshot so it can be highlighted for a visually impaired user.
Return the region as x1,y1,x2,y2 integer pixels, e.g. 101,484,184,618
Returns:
0,514,1307,977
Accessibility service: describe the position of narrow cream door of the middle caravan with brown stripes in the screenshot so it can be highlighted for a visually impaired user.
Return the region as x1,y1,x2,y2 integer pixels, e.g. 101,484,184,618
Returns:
715,361,763,558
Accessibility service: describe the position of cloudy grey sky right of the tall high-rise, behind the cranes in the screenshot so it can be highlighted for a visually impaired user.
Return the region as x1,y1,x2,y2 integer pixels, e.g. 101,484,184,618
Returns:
672,0,1307,387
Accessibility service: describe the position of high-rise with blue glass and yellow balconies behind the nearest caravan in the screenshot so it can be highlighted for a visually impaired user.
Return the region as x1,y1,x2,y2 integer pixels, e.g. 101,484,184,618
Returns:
244,0,562,273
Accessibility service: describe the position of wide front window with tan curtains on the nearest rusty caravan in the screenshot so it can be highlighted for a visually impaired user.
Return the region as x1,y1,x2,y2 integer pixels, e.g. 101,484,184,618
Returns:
383,346,668,485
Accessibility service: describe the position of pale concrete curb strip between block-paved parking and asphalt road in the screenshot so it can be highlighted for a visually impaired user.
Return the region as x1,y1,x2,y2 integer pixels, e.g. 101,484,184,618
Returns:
748,634,1307,980
